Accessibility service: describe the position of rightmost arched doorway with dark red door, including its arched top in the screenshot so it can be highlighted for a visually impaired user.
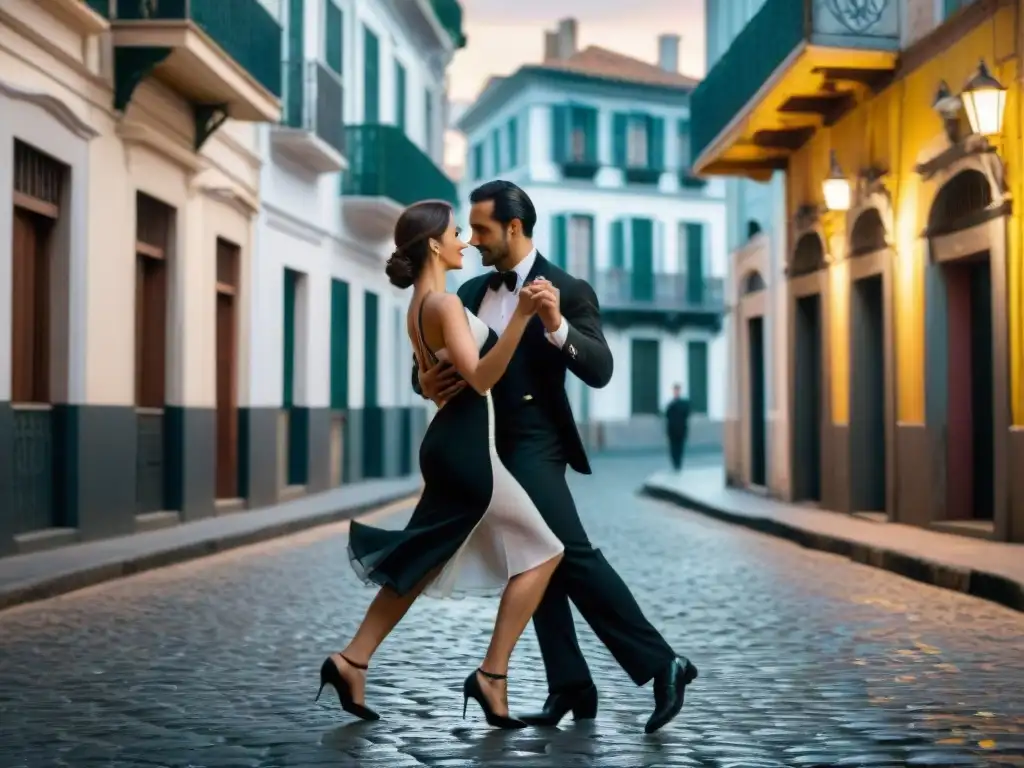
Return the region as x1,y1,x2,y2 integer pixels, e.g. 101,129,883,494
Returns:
925,168,1007,527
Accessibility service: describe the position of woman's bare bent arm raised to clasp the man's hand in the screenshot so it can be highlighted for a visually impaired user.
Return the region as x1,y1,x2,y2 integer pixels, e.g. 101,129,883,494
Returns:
428,289,532,394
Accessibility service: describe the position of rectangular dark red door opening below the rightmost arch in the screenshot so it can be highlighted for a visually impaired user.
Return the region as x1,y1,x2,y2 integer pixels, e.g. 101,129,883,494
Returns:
943,260,995,520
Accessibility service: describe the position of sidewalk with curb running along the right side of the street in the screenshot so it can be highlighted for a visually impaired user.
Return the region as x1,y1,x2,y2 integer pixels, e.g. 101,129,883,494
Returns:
641,466,1024,610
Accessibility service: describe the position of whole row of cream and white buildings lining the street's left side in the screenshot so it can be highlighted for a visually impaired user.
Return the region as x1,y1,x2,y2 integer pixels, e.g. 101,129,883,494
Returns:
0,0,464,556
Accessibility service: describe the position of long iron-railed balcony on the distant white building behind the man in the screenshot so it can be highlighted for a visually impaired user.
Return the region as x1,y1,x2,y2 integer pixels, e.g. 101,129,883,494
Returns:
594,269,725,331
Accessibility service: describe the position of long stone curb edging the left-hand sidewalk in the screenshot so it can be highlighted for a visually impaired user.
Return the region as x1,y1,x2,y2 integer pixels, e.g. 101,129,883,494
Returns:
0,490,420,611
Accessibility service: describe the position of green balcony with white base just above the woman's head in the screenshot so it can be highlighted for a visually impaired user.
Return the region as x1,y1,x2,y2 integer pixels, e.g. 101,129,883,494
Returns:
341,125,458,241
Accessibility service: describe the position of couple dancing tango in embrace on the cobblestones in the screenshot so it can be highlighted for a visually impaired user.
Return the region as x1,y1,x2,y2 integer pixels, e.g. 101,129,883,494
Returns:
317,181,697,733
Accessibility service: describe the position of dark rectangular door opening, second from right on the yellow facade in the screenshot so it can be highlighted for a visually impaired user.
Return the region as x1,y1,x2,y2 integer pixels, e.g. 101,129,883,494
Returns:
850,274,886,512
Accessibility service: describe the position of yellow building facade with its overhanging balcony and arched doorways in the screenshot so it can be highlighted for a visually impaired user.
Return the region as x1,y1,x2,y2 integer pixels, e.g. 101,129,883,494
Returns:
693,0,1024,542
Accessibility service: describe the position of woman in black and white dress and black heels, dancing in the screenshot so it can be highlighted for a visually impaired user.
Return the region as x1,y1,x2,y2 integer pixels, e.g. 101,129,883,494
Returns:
321,201,563,728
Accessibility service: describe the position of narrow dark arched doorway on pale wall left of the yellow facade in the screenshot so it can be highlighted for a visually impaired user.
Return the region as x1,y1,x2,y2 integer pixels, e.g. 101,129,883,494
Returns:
788,230,825,502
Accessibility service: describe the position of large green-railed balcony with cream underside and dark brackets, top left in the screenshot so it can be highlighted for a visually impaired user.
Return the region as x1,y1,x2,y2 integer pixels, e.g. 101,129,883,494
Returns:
112,0,282,148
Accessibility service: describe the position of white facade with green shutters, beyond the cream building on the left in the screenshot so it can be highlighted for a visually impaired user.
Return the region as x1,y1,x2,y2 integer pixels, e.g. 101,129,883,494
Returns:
247,0,462,500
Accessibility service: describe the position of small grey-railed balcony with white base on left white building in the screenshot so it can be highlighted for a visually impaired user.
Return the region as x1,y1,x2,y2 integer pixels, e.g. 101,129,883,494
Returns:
270,61,345,173
